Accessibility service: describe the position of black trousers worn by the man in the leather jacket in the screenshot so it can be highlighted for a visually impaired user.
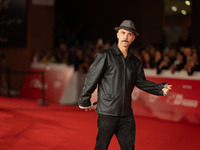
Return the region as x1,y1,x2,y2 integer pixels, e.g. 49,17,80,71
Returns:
95,114,135,150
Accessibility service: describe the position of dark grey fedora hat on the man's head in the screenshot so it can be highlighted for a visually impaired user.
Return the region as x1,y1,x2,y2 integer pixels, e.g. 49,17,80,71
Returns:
115,20,139,36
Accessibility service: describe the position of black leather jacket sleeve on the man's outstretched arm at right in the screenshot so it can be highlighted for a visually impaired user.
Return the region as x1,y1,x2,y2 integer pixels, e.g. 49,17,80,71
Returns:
136,63,166,96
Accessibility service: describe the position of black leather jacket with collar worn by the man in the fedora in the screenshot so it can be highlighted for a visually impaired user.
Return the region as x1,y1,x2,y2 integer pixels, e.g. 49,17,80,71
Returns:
78,44,165,116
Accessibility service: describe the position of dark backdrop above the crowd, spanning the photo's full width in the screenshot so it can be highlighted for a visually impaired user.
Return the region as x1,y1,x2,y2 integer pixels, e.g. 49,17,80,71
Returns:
0,0,200,70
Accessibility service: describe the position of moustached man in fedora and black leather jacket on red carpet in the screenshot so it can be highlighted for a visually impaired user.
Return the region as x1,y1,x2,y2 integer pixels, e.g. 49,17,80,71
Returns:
78,20,171,150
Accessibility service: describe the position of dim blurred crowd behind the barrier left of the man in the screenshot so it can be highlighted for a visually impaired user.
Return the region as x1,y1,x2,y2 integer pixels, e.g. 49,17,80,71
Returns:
33,39,110,73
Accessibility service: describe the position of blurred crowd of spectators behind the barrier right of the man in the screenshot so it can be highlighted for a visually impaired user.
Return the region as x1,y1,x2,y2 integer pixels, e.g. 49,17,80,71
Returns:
133,45,200,75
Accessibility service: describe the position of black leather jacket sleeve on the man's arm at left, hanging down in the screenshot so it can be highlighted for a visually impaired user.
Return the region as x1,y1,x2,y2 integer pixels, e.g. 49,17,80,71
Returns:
78,53,106,107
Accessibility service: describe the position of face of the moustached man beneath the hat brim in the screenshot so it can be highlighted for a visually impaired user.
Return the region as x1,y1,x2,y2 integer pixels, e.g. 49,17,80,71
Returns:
117,29,135,46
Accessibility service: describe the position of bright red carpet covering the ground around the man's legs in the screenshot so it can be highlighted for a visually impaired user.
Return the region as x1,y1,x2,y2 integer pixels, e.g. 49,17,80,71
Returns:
0,97,200,150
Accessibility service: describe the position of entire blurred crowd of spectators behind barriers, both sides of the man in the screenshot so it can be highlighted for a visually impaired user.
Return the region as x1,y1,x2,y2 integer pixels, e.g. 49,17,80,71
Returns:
33,38,200,75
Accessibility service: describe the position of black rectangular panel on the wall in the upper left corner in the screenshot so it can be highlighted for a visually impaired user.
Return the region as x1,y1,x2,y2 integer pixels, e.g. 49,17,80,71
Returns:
0,0,27,47
